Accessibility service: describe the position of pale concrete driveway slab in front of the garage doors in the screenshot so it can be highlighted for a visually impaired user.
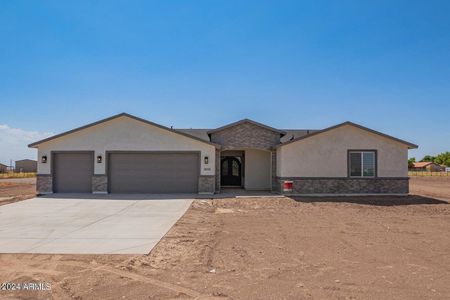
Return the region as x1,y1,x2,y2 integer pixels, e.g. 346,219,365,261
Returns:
0,195,193,254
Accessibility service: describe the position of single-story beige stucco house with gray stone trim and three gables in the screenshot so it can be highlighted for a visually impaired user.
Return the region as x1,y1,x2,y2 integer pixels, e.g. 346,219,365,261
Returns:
29,113,417,195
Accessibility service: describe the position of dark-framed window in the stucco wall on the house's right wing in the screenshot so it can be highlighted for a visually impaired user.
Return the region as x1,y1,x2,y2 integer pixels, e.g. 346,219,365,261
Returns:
348,151,377,177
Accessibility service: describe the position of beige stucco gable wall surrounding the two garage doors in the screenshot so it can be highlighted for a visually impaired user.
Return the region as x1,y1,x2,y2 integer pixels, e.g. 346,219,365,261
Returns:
38,116,215,175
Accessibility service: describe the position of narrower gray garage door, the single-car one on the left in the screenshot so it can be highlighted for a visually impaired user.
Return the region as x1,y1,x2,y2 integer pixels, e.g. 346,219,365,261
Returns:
53,152,94,193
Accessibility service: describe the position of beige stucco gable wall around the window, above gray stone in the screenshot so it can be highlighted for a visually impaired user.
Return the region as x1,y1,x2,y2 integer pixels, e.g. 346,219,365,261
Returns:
277,125,408,177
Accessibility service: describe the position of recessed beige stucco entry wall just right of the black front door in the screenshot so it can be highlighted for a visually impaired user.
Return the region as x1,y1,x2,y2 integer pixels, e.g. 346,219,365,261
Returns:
244,149,272,190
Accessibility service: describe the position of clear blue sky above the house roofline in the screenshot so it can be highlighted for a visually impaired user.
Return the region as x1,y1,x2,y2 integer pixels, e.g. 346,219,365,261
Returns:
0,0,450,162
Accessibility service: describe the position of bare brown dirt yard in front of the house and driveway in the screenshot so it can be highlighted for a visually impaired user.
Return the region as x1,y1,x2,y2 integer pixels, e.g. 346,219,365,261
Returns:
0,177,450,299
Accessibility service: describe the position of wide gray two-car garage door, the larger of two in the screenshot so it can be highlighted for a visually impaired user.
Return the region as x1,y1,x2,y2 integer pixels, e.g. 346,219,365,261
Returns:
108,152,200,194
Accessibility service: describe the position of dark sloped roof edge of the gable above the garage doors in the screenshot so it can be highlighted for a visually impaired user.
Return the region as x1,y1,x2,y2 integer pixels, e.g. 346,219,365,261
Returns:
28,113,218,148
